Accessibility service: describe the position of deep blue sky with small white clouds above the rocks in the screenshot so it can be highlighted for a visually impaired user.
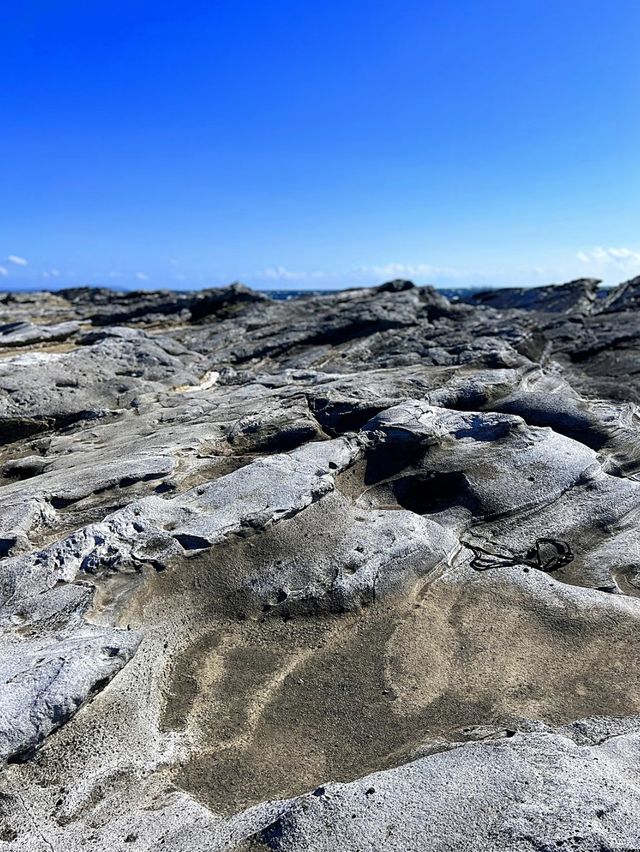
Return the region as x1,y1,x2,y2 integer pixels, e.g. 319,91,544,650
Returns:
0,0,640,289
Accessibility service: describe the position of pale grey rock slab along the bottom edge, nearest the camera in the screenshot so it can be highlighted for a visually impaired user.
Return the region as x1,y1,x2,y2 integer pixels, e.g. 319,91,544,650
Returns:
244,730,640,852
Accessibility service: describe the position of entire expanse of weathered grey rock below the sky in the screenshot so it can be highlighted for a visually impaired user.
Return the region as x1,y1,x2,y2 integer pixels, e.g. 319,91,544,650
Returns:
0,279,640,852
